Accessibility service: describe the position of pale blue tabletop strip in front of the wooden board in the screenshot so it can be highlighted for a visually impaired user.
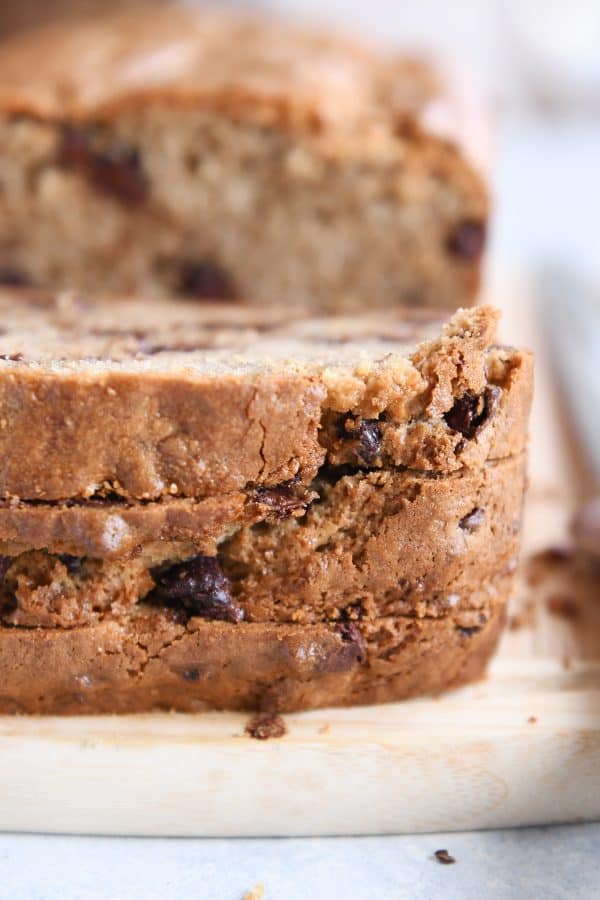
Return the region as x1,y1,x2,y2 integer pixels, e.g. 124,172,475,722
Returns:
0,824,600,900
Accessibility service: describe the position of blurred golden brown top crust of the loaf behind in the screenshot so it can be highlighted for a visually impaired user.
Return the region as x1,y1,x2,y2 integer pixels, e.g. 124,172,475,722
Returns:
0,9,450,134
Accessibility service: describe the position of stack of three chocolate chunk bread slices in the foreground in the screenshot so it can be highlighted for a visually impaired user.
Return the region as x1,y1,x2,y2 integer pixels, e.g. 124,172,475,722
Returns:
0,290,531,713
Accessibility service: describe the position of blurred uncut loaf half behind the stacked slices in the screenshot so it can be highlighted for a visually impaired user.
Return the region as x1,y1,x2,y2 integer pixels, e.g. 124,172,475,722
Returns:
0,8,489,310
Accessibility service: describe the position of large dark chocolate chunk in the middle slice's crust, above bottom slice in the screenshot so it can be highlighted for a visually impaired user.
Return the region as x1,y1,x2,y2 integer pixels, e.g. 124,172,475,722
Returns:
144,554,244,622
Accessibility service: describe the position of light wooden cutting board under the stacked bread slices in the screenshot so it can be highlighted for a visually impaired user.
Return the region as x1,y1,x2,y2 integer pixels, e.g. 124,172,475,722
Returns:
0,270,600,836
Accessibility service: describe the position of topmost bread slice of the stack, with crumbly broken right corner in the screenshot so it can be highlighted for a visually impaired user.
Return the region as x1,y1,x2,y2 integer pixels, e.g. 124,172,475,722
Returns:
0,298,532,501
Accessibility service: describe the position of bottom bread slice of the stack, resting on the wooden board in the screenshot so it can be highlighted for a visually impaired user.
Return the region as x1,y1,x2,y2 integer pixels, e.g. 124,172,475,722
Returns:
0,577,511,714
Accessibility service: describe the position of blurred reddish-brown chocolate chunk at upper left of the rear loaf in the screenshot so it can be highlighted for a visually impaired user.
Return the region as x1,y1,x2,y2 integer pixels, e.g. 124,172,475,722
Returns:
59,126,149,206
